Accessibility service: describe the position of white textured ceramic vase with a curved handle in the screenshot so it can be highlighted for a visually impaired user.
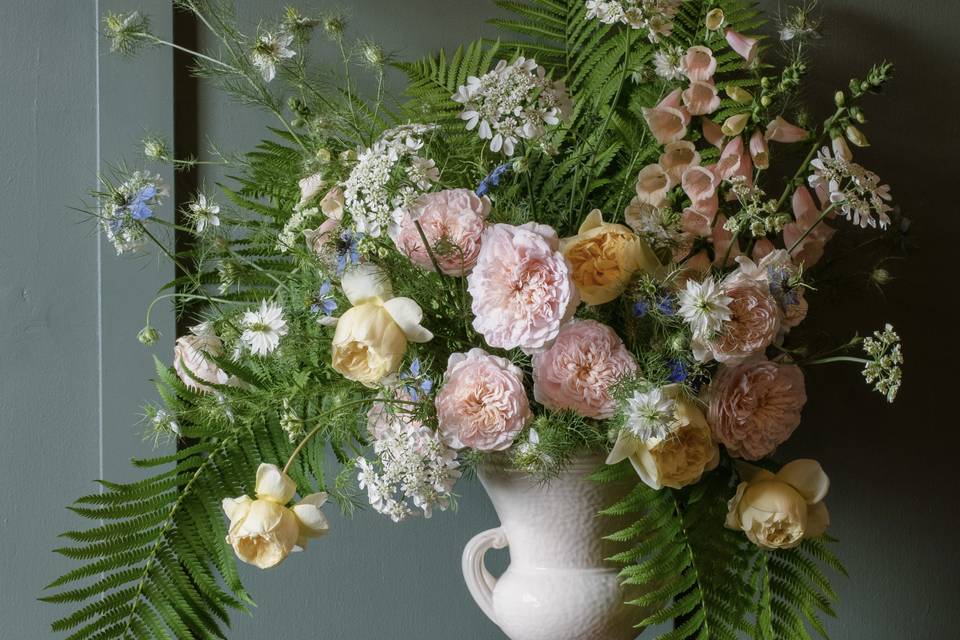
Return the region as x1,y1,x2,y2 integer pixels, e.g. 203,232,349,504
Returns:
463,456,642,640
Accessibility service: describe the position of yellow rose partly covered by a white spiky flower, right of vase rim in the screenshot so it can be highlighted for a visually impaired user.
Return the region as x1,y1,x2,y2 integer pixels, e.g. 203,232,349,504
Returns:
607,385,720,490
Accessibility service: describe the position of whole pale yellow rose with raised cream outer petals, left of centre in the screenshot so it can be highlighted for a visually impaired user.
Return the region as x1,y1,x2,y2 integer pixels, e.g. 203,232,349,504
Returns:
331,263,433,387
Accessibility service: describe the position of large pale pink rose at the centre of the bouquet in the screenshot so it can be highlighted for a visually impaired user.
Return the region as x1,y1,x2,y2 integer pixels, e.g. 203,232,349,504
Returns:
467,224,580,353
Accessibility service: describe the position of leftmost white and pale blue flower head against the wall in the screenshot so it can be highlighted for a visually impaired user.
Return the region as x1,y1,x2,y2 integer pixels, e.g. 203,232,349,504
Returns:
100,171,168,255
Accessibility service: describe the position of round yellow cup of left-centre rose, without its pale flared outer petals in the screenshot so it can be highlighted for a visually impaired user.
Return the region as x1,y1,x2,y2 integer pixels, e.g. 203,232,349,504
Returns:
332,302,407,387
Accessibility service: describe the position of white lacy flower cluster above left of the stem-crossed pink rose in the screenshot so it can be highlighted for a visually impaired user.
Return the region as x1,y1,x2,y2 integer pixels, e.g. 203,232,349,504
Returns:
341,124,440,238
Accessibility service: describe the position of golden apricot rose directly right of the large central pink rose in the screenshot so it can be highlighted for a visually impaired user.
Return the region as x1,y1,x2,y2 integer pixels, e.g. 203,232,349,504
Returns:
560,209,660,305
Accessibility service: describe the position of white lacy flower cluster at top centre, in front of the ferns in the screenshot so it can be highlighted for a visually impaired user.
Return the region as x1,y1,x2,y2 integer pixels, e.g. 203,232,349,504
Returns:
453,57,573,156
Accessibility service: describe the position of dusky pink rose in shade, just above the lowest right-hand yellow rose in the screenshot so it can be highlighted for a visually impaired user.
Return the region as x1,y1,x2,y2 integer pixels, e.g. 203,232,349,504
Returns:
707,357,807,460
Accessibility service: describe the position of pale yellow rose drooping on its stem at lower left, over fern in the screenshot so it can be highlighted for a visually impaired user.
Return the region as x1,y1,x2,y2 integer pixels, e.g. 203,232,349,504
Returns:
222,463,330,569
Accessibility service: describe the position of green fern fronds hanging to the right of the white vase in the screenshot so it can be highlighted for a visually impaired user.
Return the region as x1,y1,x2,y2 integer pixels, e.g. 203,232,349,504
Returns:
596,463,846,640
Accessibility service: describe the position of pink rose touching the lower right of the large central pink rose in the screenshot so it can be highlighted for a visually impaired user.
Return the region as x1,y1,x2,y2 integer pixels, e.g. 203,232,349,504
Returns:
533,320,637,419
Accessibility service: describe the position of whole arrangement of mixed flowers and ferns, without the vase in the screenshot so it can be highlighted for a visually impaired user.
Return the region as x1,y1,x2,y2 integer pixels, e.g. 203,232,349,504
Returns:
46,0,907,639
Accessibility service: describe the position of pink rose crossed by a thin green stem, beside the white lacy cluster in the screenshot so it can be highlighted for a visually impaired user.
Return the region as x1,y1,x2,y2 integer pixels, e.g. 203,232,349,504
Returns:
392,189,490,276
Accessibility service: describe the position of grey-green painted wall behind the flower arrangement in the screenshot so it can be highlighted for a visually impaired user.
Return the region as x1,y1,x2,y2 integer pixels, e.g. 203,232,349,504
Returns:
0,0,960,640
